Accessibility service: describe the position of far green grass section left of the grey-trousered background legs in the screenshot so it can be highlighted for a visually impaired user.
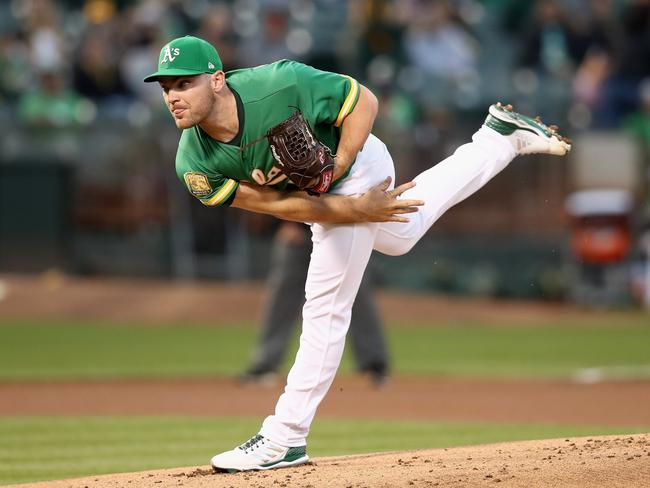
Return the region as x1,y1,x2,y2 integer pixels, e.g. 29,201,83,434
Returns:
0,321,256,380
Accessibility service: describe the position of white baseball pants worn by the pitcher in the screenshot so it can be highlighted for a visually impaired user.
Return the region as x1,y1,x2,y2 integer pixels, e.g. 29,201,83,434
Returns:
260,127,516,447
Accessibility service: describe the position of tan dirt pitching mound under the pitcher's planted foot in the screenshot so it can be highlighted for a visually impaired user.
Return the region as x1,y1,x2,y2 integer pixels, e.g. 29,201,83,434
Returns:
7,434,650,488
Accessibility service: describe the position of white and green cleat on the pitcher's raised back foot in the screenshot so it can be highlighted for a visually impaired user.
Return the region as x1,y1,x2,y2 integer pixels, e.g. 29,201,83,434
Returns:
484,103,571,156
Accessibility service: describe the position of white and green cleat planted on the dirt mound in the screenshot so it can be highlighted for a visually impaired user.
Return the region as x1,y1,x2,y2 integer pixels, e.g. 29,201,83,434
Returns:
210,434,309,473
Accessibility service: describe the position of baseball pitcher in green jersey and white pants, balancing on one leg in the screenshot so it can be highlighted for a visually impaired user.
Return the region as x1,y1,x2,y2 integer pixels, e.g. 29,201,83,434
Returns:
145,36,571,472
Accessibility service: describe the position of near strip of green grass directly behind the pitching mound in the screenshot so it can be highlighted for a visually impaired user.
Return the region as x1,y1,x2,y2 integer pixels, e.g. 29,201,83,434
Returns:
0,417,648,484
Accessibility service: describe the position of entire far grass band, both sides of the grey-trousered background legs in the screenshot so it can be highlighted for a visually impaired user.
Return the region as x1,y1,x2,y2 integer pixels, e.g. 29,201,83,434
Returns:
0,319,650,380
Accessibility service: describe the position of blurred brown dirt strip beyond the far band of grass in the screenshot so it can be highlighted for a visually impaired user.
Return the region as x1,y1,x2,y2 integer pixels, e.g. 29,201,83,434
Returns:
0,273,626,325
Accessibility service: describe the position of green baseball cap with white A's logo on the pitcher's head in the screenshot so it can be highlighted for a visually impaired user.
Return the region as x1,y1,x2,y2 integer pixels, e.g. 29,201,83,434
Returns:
144,36,223,83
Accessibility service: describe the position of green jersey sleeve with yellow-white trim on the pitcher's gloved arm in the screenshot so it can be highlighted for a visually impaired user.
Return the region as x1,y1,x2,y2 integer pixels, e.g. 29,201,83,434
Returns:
291,62,360,127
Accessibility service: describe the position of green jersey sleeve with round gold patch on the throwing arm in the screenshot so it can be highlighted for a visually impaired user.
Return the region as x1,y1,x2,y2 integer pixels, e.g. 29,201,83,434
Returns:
176,150,239,207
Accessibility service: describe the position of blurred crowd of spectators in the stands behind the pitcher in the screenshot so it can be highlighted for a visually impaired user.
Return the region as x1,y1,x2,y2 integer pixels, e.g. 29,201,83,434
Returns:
0,0,650,144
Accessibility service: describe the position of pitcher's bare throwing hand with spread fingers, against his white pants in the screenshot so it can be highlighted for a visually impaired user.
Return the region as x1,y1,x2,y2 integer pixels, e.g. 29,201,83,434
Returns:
357,176,424,222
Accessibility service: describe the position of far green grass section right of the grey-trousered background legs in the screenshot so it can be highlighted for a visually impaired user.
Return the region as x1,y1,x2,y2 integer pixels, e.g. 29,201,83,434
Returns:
390,320,650,378
